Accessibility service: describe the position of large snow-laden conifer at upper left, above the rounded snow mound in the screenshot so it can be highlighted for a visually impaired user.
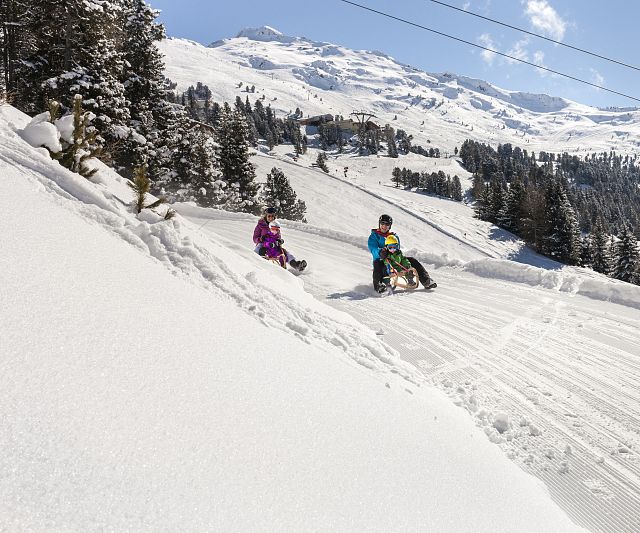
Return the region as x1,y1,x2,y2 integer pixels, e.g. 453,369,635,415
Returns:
16,0,129,157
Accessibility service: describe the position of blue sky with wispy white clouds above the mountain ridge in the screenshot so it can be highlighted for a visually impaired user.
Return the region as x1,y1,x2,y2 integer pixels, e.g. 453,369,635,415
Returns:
147,0,640,106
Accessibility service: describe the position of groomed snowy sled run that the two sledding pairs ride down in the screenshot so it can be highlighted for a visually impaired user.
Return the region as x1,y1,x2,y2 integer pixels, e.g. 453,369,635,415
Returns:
177,198,640,533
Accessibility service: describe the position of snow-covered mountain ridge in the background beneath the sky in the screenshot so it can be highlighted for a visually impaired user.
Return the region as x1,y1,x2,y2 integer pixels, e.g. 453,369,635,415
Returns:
161,26,640,153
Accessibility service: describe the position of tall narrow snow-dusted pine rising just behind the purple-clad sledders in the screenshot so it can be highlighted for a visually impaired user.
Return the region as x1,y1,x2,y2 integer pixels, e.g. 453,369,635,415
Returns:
216,103,260,214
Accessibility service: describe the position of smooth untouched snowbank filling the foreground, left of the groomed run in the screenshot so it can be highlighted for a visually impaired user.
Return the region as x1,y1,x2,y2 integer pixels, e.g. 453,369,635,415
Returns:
0,106,600,533
